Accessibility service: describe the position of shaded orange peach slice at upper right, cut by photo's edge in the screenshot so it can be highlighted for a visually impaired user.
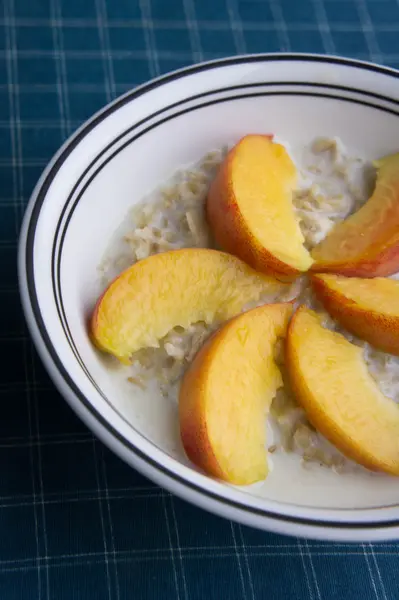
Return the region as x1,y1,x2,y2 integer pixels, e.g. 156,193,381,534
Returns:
312,153,399,277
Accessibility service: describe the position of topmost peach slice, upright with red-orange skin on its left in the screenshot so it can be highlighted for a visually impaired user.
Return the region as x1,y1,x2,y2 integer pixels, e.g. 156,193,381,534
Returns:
206,135,313,278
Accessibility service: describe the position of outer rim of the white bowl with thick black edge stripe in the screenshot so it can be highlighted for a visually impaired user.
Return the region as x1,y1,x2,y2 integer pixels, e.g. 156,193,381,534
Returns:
18,53,399,540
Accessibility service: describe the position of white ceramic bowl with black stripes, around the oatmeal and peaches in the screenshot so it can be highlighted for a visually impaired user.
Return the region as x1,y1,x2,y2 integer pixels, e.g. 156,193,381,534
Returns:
19,55,399,541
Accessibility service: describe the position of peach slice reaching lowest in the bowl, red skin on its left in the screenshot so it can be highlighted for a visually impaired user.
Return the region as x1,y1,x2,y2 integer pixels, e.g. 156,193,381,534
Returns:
179,303,292,485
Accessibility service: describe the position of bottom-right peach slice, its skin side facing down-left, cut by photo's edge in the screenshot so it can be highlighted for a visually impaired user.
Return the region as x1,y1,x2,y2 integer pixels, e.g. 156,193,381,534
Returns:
286,307,399,475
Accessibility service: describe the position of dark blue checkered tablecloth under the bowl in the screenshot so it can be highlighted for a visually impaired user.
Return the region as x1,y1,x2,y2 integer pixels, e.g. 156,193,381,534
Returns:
0,0,399,600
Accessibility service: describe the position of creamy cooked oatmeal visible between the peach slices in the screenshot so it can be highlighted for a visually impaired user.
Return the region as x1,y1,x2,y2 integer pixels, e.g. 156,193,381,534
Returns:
101,138,399,472
